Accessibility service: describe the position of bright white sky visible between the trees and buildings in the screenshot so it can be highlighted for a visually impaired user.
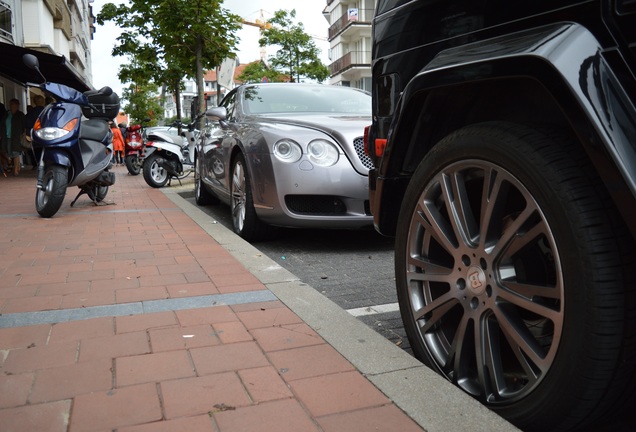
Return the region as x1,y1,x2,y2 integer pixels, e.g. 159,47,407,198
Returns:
91,0,329,96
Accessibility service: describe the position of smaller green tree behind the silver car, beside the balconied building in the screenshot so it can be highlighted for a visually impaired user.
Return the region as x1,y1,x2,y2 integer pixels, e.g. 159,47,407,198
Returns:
258,9,329,82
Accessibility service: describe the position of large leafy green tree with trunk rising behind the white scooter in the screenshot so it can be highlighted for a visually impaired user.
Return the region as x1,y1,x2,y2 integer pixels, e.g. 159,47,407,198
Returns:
97,0,241,125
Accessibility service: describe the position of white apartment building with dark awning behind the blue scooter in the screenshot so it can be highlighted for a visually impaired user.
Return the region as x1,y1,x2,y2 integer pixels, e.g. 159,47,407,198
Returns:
0,0,95,107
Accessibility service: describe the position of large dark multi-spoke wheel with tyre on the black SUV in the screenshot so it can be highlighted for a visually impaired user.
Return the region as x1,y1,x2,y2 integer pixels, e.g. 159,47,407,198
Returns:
395,123,636,431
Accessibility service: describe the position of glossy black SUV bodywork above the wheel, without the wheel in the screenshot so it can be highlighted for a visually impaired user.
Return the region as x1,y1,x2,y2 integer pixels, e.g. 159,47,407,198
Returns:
369,1,636,236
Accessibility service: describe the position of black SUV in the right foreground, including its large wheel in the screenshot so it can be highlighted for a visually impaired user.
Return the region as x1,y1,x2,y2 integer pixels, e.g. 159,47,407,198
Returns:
368,0,636,431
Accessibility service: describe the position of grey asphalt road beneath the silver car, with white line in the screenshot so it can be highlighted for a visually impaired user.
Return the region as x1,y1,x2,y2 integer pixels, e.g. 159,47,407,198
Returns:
180,191,411,353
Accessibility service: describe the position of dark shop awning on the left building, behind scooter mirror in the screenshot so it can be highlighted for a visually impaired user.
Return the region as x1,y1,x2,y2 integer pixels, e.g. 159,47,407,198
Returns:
0,42,92,91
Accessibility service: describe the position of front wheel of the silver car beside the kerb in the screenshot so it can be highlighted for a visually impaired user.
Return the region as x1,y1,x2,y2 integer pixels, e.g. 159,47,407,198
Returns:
230,153,272,241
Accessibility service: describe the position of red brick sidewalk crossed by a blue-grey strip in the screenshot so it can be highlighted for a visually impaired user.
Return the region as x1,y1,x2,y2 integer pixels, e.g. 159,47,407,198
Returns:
0,167,422,432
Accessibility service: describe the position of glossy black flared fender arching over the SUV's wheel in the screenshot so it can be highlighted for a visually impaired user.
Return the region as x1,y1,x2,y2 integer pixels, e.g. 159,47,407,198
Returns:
369,22,636,237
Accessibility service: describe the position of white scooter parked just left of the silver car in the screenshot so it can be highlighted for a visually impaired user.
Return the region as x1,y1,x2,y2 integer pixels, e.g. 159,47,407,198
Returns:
143,119,198,188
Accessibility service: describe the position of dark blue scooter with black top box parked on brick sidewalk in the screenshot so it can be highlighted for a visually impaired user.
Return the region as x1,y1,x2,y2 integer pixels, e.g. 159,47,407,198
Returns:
23,54,119,218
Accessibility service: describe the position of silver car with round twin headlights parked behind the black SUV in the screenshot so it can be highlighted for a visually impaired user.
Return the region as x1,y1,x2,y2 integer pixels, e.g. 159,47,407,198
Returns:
195,83,372,241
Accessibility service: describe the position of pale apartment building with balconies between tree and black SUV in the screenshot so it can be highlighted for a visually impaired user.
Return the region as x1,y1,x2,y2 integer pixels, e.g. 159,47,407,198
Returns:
323,0,376,91
